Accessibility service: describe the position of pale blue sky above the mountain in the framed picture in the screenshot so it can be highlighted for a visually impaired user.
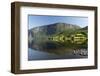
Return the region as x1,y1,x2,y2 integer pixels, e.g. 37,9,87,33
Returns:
28,15,88,29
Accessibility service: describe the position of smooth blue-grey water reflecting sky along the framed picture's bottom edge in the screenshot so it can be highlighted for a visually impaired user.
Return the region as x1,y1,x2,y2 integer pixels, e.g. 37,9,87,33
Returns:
28,48,88,61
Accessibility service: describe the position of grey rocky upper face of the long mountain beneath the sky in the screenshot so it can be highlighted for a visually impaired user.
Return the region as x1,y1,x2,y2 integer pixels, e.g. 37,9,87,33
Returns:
30,23,81,35
